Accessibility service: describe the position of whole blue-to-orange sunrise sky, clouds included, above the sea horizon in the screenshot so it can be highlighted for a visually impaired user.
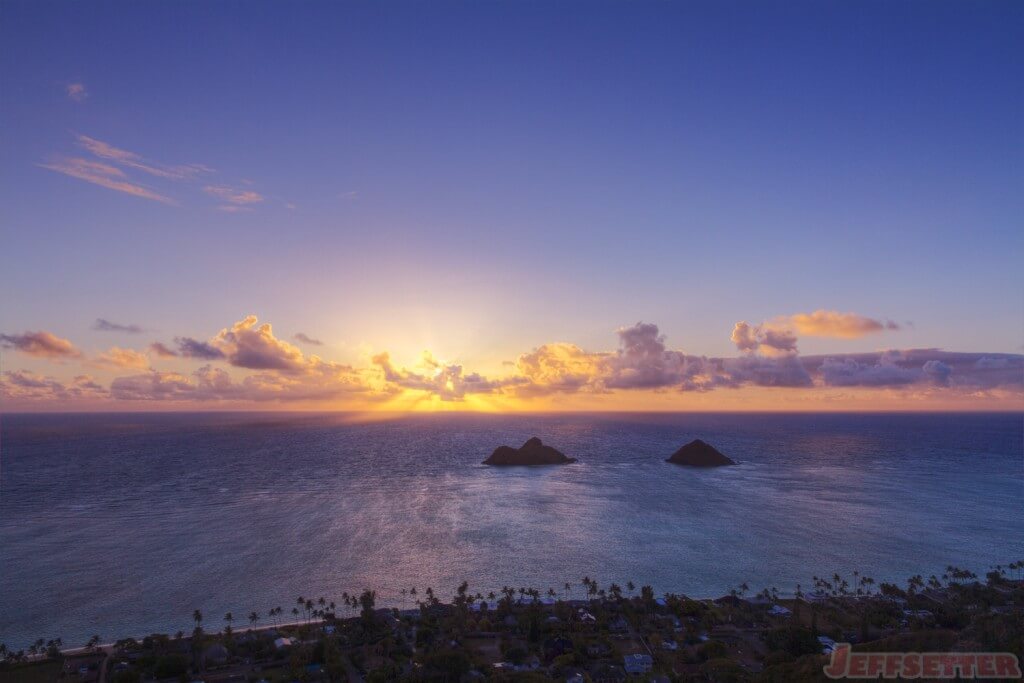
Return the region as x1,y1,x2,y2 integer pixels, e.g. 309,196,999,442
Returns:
0,0,1024,411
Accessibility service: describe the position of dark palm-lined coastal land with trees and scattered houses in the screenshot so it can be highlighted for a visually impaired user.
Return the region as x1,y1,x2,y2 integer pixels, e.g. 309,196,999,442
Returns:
0,562,1024,683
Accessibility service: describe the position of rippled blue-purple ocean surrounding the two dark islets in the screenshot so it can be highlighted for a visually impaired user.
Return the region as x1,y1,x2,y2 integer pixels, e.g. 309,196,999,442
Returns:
0,414,1024,647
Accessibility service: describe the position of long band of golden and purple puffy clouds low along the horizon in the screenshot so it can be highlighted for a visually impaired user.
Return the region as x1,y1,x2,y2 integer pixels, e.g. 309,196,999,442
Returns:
0,314,1024,402
